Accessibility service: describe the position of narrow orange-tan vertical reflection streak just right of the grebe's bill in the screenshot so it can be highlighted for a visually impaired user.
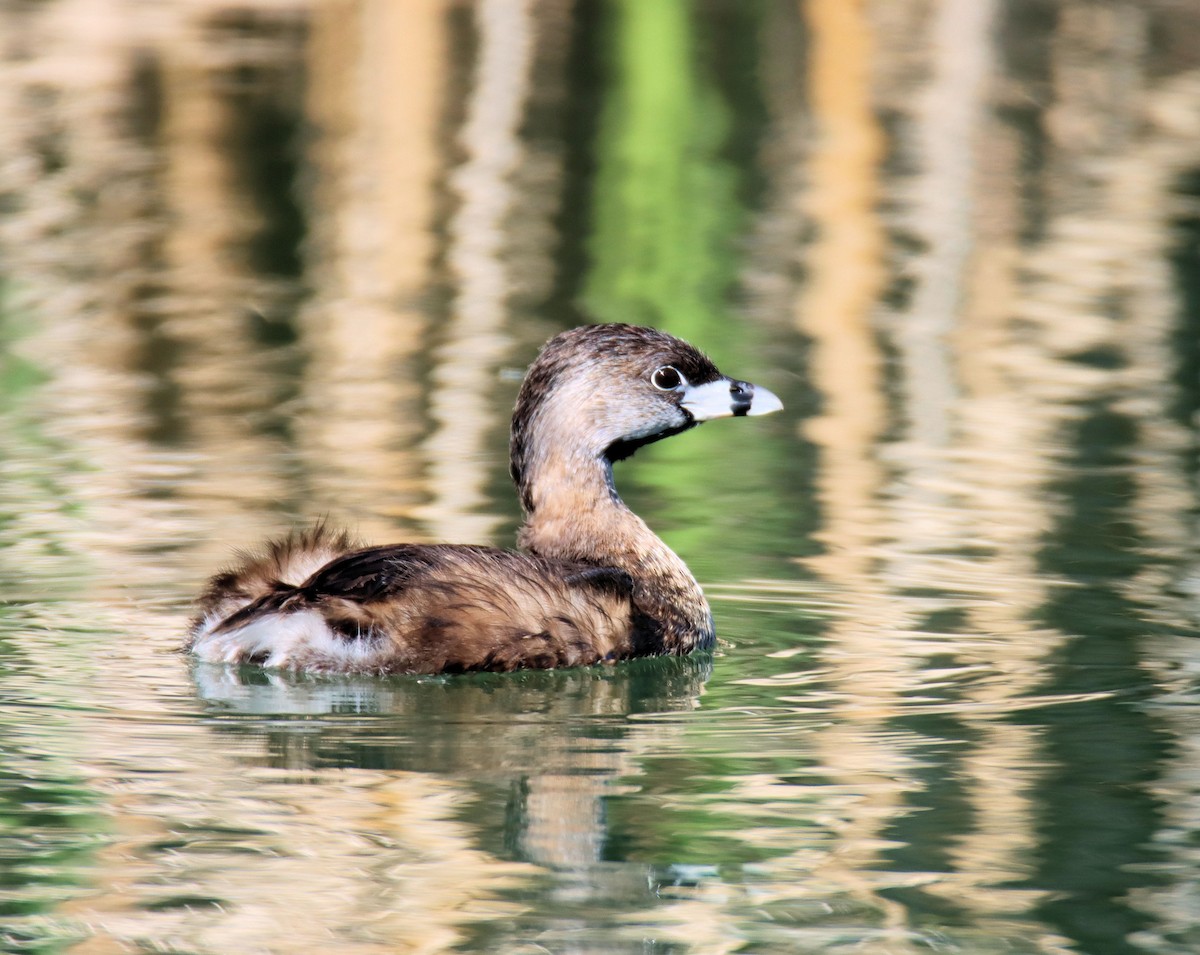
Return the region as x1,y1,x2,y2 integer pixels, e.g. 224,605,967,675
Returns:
787,0,907,924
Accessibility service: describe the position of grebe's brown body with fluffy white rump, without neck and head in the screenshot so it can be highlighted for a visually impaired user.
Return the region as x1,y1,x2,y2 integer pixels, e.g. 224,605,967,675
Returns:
191,528,653,673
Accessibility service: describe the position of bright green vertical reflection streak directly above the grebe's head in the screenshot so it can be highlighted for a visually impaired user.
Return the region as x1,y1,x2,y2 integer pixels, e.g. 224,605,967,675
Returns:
584,0,743,342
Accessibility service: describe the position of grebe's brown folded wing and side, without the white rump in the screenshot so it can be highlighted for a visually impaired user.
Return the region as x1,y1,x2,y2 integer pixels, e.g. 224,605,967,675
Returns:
199,545,648,673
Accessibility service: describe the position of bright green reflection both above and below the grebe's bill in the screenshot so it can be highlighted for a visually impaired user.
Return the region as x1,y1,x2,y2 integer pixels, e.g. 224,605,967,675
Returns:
584,0,810,578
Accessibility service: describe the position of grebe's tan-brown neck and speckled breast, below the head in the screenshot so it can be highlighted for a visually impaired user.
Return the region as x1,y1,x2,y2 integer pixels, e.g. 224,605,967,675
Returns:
512,445,713,653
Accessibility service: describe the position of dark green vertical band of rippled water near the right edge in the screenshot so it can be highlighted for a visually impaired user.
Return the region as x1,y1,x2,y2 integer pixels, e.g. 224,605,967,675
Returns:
1031,404,1172,955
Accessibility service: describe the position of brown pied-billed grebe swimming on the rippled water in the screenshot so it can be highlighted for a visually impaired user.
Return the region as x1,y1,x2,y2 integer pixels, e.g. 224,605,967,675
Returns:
191,325,782,673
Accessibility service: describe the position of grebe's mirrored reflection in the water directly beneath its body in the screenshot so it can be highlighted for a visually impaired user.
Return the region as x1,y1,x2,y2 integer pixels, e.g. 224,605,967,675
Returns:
192,653,713,867
